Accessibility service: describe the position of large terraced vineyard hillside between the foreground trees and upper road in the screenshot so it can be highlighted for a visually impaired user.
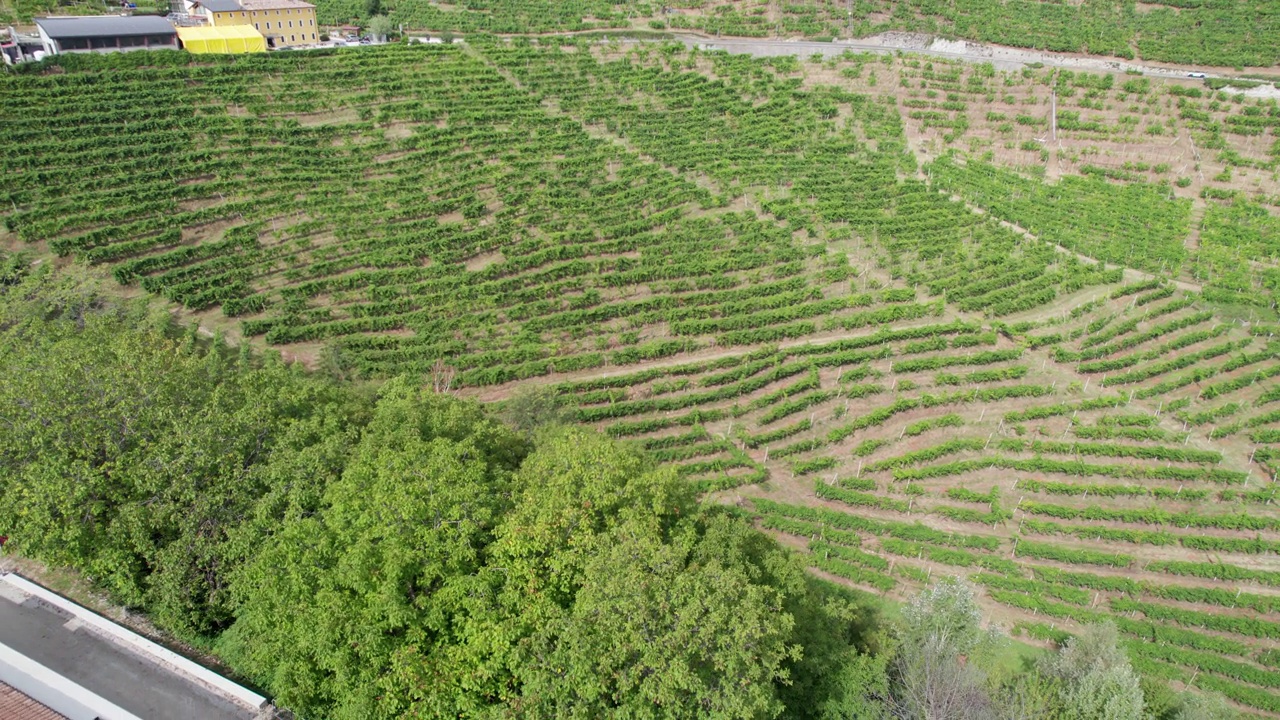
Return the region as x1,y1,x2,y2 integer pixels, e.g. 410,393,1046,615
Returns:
0,39,1280,716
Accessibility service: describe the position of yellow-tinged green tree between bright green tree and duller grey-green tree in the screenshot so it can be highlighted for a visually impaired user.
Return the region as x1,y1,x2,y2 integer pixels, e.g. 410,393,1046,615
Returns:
376,428,694,717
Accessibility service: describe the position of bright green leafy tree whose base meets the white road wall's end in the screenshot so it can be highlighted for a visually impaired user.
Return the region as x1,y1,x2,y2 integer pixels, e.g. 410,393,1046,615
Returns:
223,380,521,717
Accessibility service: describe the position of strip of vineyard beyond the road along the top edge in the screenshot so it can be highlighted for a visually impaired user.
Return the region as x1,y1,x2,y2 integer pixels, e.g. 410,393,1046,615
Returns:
272,0,1280,68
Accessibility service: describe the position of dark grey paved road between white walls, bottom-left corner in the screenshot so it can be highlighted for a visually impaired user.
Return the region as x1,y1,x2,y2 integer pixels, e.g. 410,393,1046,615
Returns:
0,596,256,720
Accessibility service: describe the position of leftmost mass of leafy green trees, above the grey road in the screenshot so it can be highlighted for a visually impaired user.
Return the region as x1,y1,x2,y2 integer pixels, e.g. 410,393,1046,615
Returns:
0,267,360,635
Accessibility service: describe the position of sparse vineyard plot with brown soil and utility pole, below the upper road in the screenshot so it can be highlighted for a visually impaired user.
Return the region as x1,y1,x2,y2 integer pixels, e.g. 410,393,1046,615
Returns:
803,54,1280,315
